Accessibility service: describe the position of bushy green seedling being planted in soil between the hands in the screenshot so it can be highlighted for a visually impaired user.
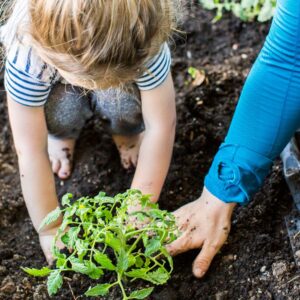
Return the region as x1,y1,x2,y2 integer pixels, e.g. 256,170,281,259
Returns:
23,190,178,300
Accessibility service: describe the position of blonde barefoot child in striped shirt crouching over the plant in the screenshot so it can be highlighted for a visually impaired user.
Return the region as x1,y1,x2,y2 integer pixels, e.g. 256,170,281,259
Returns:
2,0,178,262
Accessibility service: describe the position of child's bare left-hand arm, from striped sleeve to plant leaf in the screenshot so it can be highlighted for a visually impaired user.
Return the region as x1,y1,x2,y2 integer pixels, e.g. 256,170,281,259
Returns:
8,95,60,235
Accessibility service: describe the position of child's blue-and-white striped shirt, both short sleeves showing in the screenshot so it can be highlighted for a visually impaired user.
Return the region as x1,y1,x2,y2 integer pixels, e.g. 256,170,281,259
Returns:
4,43,171,106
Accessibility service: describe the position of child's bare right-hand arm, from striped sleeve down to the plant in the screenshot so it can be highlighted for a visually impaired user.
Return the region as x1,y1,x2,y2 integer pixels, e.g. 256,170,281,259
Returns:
131,74,176,201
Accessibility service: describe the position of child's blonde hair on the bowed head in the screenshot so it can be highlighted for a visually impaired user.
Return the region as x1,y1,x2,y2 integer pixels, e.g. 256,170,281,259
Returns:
1,0,181,89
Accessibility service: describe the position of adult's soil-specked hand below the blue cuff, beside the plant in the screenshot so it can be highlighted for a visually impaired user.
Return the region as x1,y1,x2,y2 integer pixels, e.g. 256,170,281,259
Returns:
167,188,236,278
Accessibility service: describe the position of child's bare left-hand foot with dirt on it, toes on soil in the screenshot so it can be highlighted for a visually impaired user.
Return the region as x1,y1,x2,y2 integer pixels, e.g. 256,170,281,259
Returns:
48,135,75,179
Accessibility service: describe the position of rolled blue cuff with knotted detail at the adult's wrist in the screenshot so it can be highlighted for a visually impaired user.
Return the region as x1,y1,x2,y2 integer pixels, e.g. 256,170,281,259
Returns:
204,143,273,205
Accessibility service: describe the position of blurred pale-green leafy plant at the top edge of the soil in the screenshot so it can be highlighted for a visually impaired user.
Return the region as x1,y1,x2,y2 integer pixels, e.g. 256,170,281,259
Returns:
200,0,276,22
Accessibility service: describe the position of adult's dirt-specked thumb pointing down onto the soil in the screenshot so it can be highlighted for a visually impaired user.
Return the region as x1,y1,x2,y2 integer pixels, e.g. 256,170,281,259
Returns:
193,241,221,278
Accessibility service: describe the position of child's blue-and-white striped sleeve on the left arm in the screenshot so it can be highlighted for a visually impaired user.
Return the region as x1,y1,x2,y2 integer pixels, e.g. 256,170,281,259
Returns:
4,43,52,107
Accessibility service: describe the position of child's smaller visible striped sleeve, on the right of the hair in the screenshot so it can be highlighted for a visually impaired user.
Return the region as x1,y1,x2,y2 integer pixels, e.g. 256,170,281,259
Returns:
136,43,171,91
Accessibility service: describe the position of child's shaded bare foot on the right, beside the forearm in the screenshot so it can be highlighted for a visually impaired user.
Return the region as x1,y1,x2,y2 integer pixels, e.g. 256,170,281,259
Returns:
113,133,144,169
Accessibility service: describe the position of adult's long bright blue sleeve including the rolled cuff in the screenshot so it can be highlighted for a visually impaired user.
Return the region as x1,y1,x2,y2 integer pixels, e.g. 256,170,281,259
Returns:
205,0,300,204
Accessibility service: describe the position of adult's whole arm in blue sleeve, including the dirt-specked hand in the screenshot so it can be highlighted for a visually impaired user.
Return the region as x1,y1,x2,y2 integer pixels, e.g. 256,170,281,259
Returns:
169,0,300,277
